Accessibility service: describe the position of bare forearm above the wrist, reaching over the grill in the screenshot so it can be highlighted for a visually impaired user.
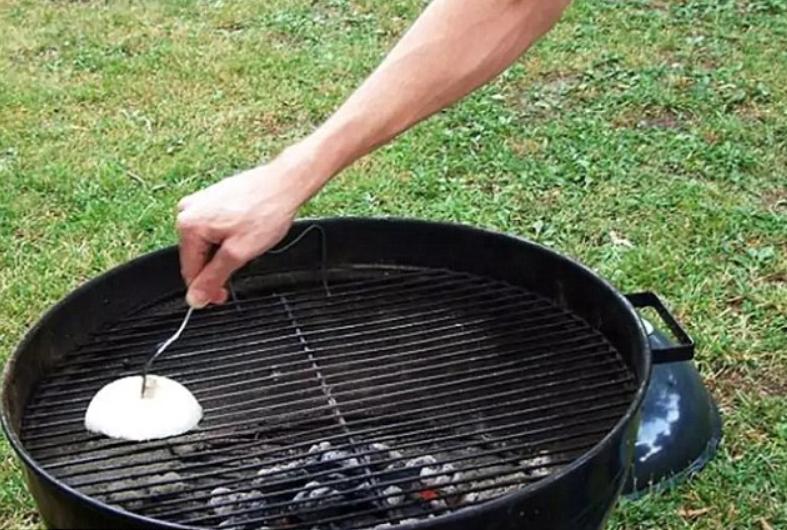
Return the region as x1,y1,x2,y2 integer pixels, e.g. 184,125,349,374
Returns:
284,0,569,196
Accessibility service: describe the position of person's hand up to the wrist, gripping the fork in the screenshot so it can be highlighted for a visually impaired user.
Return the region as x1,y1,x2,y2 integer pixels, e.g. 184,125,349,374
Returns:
177,155,310,308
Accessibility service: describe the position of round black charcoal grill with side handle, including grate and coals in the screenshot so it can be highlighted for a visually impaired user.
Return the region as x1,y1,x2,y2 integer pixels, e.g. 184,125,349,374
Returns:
3,219,692,529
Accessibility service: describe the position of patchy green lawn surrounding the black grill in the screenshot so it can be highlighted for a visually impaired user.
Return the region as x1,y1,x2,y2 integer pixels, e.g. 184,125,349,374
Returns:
0,0,787,530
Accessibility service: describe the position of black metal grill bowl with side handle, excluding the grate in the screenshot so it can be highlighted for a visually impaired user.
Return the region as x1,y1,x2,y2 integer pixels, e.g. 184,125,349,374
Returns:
2,218,693,530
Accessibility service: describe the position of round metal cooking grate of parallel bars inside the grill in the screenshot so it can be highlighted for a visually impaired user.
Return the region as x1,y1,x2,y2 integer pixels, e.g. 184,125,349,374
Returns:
22,266,636,529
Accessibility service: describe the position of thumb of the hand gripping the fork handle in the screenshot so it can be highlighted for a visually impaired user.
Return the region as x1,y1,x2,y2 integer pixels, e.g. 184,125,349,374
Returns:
186,241,248,309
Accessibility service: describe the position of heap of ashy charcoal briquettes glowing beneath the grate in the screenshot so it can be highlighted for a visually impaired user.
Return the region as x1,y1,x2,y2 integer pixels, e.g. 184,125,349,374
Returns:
206,441,554,530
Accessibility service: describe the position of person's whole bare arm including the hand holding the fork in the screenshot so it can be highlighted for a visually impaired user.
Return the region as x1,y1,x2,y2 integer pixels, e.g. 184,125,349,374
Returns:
178,0,569,307
